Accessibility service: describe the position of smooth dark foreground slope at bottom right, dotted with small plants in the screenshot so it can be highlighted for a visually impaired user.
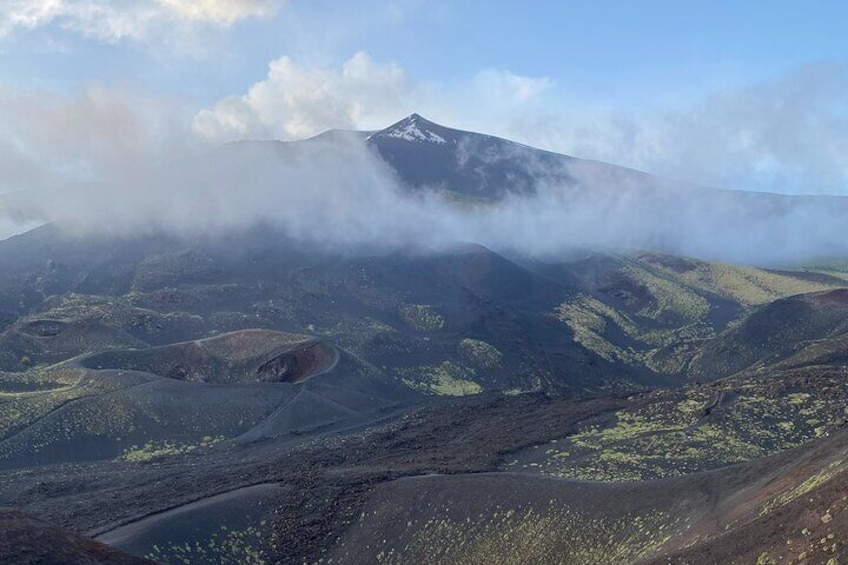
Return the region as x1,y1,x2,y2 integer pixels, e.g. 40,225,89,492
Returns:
331,424,848,565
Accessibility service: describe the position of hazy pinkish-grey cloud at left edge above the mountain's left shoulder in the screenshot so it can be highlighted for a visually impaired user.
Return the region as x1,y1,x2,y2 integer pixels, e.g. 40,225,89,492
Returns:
0,85,191,191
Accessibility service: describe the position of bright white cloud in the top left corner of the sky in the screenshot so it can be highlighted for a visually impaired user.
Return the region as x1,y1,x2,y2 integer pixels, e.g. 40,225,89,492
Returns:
0,0,283,43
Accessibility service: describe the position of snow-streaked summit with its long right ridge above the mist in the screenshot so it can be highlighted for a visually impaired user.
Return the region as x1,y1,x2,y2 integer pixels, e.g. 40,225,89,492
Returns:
370,114,845,205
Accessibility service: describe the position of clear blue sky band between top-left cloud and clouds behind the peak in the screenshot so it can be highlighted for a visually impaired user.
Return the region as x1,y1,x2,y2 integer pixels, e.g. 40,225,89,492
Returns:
6,0,848,104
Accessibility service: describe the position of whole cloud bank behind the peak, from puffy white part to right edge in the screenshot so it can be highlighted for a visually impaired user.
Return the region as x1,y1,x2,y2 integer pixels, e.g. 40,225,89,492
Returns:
194,53,848,194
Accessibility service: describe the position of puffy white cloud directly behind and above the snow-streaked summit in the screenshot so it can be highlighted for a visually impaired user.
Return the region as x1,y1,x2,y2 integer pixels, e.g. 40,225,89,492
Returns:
194,52,552,141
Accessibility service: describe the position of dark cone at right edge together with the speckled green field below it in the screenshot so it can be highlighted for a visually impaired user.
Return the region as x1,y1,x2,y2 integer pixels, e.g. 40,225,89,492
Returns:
505,289,848,481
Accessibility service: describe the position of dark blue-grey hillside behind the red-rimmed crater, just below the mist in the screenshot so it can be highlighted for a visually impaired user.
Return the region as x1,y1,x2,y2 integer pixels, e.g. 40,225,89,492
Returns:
0,227,647,395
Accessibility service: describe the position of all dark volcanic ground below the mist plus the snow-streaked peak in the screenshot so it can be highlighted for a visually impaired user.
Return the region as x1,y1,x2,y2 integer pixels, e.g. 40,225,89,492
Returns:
0,116,848,565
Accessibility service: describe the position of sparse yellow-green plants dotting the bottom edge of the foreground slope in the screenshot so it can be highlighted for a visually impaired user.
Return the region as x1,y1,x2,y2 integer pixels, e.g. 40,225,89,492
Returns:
368,499,688,565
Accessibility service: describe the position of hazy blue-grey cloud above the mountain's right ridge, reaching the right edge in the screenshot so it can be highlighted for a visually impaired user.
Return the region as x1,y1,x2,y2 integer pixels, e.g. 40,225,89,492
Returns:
502,65,848,194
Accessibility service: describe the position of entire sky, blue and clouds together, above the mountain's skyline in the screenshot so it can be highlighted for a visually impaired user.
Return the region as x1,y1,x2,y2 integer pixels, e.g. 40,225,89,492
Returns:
0,0,848,193
